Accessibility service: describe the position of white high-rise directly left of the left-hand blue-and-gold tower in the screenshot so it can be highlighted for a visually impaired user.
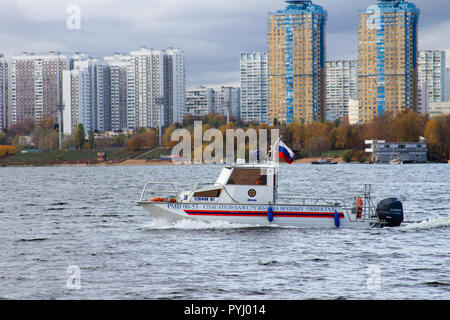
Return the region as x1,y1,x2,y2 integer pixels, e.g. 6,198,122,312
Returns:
240,52,269,123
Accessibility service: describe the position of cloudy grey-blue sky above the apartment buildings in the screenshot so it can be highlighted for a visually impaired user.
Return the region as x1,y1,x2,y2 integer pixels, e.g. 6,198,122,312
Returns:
0,0,450,86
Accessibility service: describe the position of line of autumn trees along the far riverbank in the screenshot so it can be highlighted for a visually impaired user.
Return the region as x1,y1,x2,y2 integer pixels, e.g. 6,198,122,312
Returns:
0,110,450,162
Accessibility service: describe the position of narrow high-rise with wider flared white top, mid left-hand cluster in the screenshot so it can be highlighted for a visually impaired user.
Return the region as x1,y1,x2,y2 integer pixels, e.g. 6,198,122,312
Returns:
104,53,130,131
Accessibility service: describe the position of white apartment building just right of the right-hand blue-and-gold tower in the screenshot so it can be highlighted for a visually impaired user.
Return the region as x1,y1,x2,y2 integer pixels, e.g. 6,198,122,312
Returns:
418,50,447,112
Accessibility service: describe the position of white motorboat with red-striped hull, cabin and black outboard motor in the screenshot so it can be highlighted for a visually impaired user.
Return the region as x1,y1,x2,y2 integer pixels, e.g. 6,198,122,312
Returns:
139,162,403,228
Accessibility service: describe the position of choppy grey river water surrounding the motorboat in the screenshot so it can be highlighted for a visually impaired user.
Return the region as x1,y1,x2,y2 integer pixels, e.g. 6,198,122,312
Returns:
0,164,450,299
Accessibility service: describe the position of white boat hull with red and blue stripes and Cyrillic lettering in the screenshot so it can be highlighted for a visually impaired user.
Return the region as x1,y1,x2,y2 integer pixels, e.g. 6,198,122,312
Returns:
139,201,374,228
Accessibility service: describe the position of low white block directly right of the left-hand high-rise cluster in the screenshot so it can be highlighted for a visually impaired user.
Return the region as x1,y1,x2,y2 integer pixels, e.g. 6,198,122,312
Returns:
186,86,214,116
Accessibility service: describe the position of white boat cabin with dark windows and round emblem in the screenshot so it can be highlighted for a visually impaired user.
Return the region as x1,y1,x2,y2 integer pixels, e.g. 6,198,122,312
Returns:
181,164,277,204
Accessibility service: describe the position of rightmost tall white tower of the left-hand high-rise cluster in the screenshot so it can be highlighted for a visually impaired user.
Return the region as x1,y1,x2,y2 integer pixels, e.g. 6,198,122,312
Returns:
164,48,186,124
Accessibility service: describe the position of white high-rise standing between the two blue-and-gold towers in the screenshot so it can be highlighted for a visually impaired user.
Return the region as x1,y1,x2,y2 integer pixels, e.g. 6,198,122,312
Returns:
326,60,358,121
